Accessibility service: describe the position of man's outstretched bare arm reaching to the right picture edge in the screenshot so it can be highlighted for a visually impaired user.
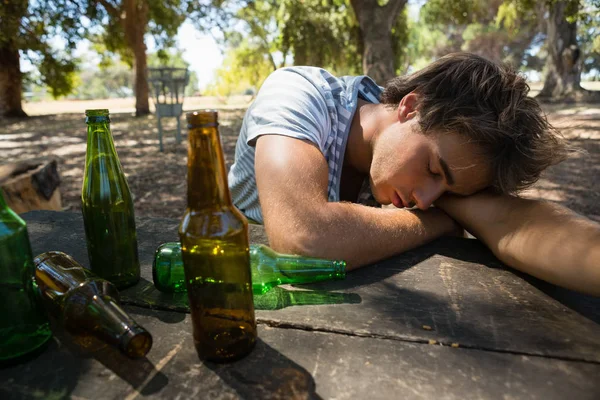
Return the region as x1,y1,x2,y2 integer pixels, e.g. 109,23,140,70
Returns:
436,192,600,296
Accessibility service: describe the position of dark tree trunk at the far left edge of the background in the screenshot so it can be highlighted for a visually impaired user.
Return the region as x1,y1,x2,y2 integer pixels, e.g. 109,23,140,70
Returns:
0,45,27,117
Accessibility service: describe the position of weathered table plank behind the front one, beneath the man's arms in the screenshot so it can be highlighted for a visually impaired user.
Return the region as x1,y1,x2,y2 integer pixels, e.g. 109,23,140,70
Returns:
25,212,600,362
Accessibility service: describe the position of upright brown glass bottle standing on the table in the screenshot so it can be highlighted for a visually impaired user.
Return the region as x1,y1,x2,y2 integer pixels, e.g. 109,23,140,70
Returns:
179,110,256,362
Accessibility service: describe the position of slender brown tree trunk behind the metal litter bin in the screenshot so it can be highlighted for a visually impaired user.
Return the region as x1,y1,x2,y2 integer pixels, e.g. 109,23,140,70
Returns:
123,0,150,117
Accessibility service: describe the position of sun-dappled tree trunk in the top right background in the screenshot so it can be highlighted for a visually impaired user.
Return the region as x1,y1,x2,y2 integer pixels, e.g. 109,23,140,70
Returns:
537,1,600,101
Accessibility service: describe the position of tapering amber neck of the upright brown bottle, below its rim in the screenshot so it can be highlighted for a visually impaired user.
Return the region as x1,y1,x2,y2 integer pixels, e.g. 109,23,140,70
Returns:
188,126,231,210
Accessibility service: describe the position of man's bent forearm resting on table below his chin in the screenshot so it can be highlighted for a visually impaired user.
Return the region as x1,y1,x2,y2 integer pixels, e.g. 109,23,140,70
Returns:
267,203,458,269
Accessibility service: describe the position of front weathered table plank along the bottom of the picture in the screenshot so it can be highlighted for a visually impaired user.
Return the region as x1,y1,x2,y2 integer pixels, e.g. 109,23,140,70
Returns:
0,307,600,400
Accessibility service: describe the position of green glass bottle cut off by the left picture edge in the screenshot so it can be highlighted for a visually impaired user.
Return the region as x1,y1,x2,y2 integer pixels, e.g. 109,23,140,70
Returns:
0,191,52,362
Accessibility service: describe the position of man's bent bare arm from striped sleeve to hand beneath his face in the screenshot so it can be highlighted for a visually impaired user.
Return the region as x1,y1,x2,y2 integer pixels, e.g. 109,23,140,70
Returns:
255,135,457,269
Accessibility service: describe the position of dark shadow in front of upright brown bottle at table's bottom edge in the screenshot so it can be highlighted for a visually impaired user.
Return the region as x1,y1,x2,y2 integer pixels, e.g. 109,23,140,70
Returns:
204,338,321,400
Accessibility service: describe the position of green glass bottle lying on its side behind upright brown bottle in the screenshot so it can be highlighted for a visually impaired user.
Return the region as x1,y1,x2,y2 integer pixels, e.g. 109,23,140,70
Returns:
152,242,346,294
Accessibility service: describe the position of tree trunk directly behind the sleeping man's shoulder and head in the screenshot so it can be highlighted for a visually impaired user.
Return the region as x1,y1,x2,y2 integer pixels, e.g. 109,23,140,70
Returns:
351,0,406,85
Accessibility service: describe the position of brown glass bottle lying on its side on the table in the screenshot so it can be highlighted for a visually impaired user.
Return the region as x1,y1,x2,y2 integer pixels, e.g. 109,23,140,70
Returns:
34,251,152,358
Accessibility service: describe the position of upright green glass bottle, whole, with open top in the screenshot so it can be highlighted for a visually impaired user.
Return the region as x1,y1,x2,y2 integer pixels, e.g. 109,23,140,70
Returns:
81,110,140,289
